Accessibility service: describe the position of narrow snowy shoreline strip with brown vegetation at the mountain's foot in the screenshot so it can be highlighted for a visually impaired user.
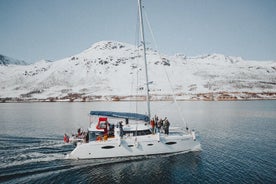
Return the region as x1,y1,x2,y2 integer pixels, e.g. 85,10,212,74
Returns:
0,92,276,103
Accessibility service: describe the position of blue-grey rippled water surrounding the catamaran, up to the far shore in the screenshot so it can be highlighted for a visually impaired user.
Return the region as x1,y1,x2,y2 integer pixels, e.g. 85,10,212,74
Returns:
0,101,276,183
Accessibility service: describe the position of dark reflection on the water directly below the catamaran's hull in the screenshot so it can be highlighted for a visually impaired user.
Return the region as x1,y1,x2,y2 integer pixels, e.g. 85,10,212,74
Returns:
63,152,201,183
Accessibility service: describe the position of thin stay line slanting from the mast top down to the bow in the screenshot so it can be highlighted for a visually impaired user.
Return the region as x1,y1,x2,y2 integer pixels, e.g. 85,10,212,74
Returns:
144,10,188,127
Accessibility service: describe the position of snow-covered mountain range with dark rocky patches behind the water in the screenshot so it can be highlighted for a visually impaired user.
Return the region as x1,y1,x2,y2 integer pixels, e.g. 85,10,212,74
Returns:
0,41,276,101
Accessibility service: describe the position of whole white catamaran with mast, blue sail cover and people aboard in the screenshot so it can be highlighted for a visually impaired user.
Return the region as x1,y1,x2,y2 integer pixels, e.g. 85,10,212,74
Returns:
67,0,201,159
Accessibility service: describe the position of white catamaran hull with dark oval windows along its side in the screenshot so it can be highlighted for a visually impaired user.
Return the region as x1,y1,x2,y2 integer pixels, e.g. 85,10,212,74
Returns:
67,133,201,159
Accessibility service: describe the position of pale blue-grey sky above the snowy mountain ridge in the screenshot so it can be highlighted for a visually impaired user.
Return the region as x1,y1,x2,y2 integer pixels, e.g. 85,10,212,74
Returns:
0,0,276,63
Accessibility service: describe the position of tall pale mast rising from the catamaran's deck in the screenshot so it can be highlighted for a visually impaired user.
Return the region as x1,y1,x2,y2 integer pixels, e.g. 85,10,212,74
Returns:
138,0,150,118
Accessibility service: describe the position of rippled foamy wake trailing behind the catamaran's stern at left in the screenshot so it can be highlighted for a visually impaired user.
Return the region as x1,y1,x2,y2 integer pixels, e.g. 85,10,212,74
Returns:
0,135,73,182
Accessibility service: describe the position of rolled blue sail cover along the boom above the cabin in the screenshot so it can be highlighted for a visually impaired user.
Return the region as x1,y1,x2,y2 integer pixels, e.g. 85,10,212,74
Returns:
90,111,149,122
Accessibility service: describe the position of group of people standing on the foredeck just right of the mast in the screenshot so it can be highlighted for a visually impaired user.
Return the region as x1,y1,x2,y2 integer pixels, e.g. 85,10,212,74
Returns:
150,115,170,135
